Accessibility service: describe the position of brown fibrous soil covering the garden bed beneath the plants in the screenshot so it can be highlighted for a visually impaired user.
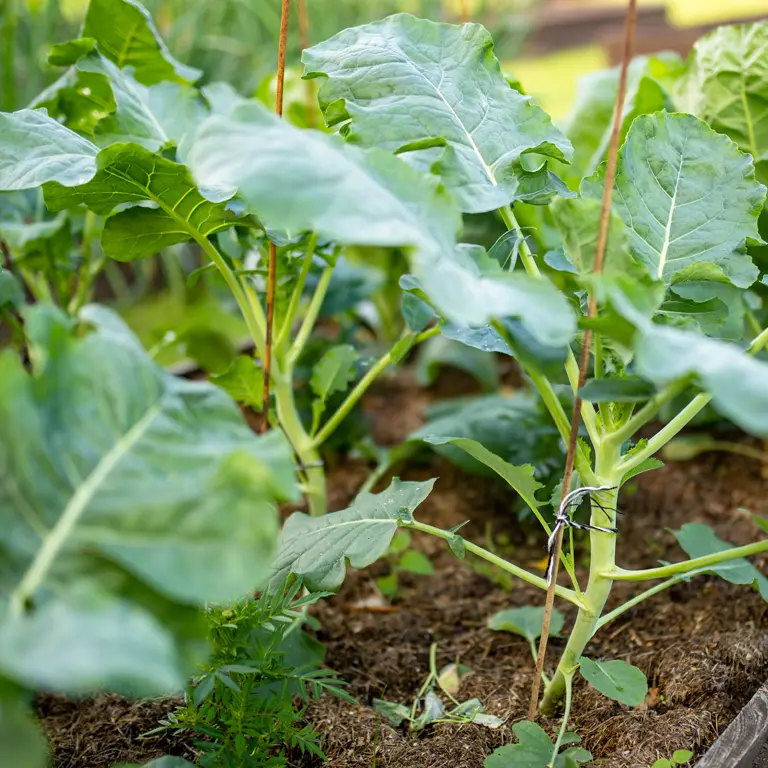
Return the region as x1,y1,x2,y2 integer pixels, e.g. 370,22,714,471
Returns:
39,366,768,768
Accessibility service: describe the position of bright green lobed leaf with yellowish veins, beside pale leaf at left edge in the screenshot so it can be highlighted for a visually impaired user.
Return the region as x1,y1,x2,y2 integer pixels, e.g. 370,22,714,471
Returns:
45,144,235,261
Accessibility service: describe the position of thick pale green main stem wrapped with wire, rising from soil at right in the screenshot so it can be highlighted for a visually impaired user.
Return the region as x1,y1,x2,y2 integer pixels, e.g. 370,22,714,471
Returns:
540,444,621,715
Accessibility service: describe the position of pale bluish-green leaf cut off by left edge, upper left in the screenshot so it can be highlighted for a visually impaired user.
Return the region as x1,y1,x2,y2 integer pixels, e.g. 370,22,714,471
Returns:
0,109,99,191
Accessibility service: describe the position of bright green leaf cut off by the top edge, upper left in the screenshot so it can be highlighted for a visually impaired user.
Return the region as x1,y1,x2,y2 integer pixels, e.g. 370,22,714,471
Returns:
82,0,202,85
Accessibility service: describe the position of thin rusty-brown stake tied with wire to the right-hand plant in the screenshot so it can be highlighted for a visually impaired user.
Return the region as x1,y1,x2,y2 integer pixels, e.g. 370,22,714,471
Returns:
528,0,637,720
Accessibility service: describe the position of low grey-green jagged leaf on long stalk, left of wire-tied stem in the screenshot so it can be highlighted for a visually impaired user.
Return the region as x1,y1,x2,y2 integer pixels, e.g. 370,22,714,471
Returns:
270,478,435,590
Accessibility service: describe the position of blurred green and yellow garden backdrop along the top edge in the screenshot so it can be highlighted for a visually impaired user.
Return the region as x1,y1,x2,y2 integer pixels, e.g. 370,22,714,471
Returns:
0,0,768,118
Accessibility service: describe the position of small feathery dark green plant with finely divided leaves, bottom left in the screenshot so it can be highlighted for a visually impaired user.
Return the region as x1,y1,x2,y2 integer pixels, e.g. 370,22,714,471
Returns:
158,581,353,768
